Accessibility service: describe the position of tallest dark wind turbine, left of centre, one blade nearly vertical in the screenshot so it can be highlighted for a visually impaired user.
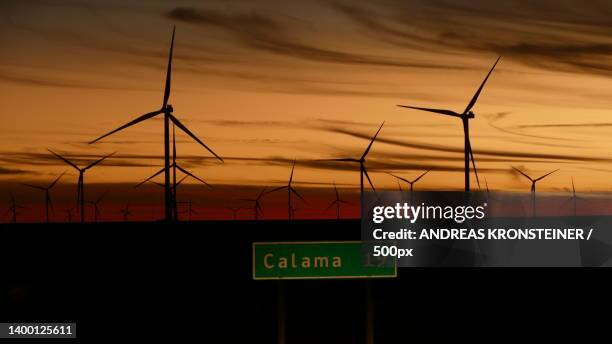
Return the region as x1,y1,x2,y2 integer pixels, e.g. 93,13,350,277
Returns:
89,28,223,221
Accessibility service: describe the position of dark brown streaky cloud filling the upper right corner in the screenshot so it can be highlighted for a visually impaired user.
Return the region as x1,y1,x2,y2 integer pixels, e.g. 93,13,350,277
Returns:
332,0,612,76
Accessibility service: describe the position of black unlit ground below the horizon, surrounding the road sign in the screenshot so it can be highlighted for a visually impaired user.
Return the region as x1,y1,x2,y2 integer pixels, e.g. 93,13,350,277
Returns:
0,221,612,343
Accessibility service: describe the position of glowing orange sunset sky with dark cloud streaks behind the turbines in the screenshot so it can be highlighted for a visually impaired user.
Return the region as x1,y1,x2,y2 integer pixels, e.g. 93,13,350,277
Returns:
0,0,612,219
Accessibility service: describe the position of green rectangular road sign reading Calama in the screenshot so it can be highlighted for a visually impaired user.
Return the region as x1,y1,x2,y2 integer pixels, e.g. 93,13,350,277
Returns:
253,241,397,280
